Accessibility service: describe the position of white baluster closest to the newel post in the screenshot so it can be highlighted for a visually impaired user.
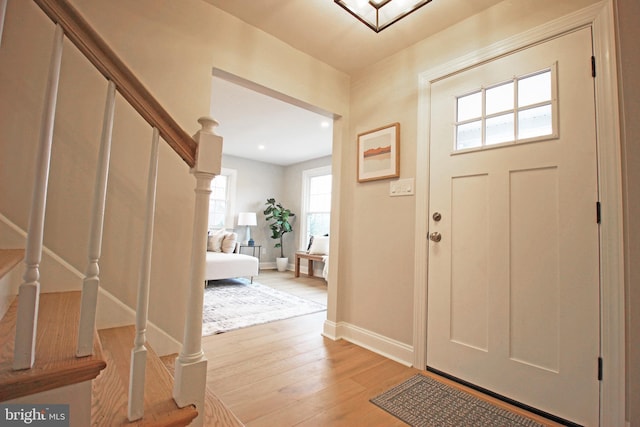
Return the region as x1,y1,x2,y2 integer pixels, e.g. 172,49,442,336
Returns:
127,128,160,421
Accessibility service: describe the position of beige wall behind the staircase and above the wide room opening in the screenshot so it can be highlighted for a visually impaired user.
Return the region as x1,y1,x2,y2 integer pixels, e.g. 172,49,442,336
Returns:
0,0,349,339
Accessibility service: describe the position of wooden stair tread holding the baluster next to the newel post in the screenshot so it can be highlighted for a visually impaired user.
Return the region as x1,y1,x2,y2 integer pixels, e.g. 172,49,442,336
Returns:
91,326,198,426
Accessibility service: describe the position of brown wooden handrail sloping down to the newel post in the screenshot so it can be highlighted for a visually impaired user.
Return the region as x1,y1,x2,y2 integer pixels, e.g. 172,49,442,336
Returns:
34,0,197,167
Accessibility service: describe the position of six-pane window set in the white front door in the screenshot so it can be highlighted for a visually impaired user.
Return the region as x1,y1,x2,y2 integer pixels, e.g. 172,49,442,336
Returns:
454,64,558,151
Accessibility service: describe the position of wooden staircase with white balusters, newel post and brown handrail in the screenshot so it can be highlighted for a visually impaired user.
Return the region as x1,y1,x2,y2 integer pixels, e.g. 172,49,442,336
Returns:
0,0,242,426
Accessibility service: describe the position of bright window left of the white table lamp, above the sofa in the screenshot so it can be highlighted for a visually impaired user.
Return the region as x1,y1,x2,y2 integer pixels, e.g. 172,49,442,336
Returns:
209,168,237,231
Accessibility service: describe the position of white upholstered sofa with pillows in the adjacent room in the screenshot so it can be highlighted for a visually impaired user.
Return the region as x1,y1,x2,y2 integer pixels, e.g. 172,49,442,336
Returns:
204,230,259,282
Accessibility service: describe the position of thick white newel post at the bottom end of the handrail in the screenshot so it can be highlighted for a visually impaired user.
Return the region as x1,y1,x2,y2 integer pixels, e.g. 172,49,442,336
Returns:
173,117,222,426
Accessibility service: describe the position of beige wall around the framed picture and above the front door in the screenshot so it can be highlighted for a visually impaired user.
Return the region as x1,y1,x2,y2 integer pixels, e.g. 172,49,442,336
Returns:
339,0,594,344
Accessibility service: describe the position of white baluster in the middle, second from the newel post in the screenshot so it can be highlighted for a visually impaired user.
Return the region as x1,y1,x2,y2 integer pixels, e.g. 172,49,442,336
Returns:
76,82,116,357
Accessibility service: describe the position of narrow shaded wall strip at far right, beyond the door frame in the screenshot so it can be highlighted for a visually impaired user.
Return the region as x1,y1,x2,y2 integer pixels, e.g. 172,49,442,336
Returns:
615,0,640,427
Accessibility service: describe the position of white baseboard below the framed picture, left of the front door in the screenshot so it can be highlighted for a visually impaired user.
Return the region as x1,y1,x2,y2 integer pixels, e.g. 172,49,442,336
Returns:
323,320,413,367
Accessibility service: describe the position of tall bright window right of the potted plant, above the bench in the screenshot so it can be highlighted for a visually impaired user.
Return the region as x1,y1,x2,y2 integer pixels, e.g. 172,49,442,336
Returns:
300,166,331,250
